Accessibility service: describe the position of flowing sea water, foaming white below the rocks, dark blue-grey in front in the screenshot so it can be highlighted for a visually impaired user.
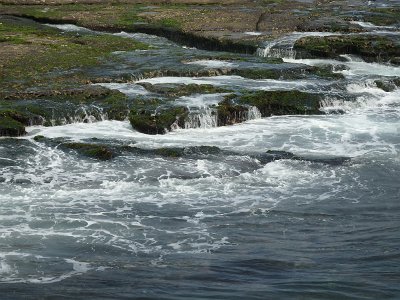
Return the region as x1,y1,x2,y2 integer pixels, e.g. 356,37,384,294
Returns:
0,20,400,299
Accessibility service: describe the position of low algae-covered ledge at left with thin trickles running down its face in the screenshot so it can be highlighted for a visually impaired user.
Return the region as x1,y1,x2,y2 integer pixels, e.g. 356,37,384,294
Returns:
0,87,129,126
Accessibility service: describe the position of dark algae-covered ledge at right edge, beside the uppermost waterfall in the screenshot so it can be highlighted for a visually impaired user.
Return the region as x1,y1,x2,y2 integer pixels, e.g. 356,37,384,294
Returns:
294,35,400,61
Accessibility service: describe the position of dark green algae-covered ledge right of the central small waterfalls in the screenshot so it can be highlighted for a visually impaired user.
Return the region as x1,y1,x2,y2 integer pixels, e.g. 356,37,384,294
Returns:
236,90,322,117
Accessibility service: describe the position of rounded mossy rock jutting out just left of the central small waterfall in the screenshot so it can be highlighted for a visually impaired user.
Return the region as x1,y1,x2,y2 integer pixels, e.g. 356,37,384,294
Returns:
129,107,189,134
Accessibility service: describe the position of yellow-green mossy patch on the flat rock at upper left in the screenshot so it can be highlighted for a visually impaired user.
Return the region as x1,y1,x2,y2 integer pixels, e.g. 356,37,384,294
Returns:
0,18,148,89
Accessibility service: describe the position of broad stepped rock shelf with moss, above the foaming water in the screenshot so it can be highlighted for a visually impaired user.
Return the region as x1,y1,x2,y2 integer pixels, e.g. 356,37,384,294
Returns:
0,1,399,136
